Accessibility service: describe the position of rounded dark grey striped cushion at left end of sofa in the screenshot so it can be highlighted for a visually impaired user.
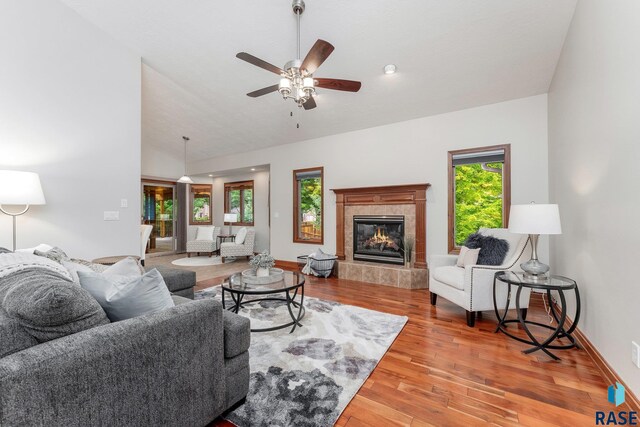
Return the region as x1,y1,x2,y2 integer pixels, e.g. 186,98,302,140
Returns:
0,268,109,342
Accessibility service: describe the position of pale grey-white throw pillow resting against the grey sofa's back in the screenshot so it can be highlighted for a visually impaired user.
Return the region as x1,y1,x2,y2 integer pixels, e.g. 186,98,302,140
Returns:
78,268,175,322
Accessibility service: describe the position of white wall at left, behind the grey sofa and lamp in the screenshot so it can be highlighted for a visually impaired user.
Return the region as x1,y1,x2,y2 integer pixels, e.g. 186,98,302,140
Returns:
0,0,140,259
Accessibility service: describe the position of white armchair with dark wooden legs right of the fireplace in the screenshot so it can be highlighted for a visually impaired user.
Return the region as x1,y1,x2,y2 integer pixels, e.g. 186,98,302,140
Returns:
429,228,531,327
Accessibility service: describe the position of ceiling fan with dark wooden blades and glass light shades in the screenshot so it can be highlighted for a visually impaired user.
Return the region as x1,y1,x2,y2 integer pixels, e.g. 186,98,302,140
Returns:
236,0,362,110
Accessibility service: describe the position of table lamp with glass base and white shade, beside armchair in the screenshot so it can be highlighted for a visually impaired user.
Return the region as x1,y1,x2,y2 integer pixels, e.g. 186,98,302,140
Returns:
509,202,562,280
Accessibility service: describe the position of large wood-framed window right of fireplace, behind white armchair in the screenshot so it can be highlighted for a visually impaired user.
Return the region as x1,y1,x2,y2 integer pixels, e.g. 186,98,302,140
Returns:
448,144,511,253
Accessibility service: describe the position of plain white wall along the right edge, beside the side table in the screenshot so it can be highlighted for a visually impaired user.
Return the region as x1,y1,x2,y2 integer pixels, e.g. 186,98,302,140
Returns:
549,0,640,395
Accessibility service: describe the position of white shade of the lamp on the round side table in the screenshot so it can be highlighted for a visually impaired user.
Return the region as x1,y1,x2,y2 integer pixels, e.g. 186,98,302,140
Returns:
509,203,562,234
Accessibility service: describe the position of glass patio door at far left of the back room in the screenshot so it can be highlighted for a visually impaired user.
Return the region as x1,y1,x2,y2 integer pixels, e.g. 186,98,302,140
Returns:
142,182,177,254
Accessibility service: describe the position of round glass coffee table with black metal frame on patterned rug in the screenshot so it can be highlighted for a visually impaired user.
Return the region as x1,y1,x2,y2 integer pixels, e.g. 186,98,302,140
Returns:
222,271,305,333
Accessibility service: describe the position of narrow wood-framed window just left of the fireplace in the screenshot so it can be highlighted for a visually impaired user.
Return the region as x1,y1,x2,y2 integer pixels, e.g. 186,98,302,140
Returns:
293,167,324,244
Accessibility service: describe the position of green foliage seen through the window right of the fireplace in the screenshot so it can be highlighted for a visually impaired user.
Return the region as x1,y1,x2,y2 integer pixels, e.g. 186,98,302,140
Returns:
454,163,503,246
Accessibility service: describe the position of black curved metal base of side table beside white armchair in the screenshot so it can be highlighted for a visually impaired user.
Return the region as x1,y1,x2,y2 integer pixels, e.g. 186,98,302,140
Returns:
493,273,580,360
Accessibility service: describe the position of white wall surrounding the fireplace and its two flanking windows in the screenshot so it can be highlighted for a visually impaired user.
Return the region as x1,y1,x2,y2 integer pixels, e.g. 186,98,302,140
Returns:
189,95,548,261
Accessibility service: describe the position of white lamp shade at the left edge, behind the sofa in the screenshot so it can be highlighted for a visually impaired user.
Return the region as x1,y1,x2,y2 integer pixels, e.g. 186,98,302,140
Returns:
0,170,46,205
